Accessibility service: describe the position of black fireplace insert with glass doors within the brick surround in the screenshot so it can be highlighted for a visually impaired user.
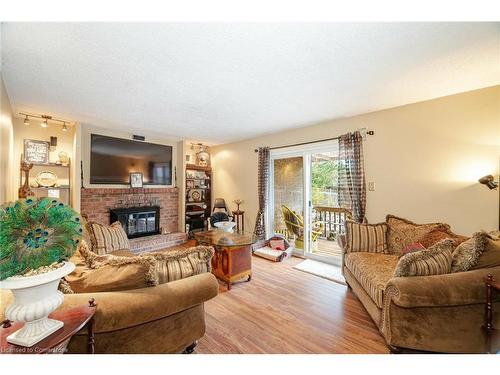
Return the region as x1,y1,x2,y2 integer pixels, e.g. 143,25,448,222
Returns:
109,206,160,238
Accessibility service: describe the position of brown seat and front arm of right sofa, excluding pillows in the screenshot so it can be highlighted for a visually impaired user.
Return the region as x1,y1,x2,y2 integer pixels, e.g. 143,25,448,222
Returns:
342,219,500,353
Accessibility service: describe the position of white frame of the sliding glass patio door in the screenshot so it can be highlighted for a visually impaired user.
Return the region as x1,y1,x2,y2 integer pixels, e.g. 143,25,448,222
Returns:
266,141,338,265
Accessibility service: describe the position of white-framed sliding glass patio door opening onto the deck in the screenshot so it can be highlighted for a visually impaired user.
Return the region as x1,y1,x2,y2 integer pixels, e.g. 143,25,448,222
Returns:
267,141,343,264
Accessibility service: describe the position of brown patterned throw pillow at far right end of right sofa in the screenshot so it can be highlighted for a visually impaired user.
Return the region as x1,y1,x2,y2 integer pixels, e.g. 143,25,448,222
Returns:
451,231,500,272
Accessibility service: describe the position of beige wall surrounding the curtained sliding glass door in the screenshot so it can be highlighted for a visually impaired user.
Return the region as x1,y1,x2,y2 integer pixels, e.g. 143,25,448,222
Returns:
211,86,500,234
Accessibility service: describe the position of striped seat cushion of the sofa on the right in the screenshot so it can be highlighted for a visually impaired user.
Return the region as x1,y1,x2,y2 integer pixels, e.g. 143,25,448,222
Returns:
344,252,398,308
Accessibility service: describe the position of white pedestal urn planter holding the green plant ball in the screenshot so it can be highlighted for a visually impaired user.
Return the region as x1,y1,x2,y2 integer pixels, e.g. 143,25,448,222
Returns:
0,262,75,347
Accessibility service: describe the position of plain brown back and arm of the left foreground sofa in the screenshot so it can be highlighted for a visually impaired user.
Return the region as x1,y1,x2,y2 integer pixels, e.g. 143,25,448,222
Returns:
0,245,218,353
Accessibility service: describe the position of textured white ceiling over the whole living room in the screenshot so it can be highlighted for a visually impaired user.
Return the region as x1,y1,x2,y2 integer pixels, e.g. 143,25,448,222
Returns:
2,23,500,144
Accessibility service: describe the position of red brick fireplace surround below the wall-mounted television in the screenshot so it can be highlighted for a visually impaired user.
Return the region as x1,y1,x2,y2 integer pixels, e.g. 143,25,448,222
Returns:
80,188,179,233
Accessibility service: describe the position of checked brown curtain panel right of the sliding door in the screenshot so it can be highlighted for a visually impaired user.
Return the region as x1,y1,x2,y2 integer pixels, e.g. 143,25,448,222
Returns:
337,131,366,223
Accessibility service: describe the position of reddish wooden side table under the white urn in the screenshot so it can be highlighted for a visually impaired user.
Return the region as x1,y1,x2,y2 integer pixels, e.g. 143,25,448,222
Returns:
0,299,97,354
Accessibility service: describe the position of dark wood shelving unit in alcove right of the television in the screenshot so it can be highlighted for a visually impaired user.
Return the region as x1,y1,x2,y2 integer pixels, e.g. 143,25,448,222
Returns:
185,164,212,232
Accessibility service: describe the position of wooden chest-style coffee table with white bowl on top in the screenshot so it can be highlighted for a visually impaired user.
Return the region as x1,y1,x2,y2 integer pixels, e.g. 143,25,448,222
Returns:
194,229,257,290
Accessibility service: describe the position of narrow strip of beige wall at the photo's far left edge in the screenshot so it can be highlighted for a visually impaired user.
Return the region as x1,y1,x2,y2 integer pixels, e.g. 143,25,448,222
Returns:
0,75,15,204
